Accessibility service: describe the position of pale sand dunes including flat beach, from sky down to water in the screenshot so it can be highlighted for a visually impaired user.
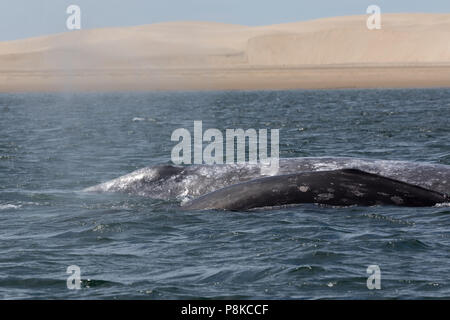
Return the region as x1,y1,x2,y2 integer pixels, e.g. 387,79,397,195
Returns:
0,14,450,91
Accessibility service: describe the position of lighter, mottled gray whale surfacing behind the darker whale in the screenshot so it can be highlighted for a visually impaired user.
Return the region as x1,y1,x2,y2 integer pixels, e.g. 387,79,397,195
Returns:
84,157,450,201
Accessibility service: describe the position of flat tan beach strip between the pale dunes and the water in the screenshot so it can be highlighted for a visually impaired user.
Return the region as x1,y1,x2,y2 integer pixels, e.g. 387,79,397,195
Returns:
0,66,450,92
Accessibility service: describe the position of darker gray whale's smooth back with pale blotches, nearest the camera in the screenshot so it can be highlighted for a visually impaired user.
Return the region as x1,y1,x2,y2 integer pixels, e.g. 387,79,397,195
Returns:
183,169,449,210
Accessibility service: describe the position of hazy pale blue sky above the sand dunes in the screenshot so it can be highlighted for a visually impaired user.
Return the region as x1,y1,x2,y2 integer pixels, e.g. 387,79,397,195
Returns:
0,0,450,41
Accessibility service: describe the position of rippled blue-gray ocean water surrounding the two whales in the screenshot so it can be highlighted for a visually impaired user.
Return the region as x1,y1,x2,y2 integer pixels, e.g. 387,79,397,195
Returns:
0,89,450,299
